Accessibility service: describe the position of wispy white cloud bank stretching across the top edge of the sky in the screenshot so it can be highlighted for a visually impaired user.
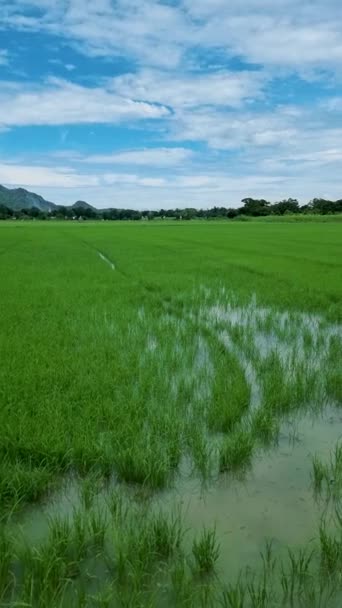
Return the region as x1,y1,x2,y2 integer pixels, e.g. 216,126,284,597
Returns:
0,0,342,71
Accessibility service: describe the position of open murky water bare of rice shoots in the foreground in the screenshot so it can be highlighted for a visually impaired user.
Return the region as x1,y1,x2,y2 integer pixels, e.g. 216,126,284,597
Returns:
15,408,342,580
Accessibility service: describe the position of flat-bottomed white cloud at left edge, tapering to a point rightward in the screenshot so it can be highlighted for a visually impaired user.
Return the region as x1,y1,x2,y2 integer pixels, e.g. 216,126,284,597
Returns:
0,79,169,127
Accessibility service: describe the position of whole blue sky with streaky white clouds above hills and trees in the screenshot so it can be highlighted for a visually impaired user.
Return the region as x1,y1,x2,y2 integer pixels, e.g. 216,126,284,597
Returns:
0,0,342,209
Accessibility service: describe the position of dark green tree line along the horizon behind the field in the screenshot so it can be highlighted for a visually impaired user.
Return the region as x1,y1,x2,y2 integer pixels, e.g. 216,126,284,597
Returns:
0,198,342,221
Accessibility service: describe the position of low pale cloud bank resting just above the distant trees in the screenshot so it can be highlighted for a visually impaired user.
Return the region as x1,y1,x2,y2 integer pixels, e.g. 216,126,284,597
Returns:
28,173,341,209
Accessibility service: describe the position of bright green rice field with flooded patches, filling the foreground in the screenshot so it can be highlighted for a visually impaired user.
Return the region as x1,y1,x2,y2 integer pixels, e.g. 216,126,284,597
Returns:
0,221,342,608
